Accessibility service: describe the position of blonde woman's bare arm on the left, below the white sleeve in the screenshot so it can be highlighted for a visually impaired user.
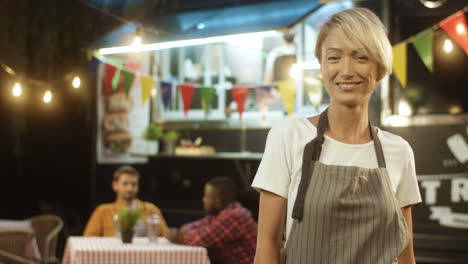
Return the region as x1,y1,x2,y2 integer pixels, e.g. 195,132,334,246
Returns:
254,190,287,264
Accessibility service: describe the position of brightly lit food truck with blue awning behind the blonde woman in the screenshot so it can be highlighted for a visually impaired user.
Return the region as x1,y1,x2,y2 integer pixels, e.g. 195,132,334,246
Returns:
90,0,468,263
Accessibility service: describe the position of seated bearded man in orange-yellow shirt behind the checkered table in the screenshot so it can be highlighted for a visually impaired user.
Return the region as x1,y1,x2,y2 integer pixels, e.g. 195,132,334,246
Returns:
83,166,169,237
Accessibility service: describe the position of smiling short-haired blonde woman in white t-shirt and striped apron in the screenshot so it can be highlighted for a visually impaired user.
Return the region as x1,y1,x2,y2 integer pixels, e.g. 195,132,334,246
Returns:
252,8,421,264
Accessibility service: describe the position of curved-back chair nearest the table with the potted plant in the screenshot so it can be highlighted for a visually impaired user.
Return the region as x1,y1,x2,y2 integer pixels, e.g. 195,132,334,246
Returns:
29,215,63,263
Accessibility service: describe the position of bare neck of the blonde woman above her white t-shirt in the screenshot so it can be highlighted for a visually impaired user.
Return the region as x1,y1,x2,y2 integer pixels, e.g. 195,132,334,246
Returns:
325,104,372,144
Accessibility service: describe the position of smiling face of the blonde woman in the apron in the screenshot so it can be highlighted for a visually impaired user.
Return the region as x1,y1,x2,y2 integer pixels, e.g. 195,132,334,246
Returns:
320,31,378,107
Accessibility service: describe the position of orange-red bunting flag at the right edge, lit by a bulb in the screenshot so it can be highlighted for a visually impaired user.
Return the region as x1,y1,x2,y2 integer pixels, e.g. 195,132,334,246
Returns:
439,11,468,54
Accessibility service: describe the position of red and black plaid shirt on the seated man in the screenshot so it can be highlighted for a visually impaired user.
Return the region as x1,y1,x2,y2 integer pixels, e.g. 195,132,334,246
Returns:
182,203,257,264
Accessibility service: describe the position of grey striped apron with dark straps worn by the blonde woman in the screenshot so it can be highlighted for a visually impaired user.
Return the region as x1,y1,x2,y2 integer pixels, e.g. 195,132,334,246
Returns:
284,110,410,264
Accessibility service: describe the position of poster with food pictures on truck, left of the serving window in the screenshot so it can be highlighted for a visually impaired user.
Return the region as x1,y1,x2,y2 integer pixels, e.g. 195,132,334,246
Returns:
96,58,150,164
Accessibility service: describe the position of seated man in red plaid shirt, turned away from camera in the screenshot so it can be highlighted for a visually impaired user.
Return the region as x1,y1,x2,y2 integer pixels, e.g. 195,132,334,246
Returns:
174,177,257,264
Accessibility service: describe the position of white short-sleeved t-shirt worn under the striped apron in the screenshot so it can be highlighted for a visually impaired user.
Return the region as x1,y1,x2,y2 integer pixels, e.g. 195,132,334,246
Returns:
252,117,422,237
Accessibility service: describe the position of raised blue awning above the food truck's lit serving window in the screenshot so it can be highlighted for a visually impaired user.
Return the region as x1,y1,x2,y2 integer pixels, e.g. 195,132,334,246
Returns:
90,0,320,49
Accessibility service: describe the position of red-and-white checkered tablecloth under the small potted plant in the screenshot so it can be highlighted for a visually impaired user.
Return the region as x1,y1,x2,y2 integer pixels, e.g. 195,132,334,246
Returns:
62,237,210,264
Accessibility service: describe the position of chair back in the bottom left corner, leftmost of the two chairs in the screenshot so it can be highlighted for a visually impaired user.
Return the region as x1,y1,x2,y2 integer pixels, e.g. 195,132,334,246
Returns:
0,231,38,264
